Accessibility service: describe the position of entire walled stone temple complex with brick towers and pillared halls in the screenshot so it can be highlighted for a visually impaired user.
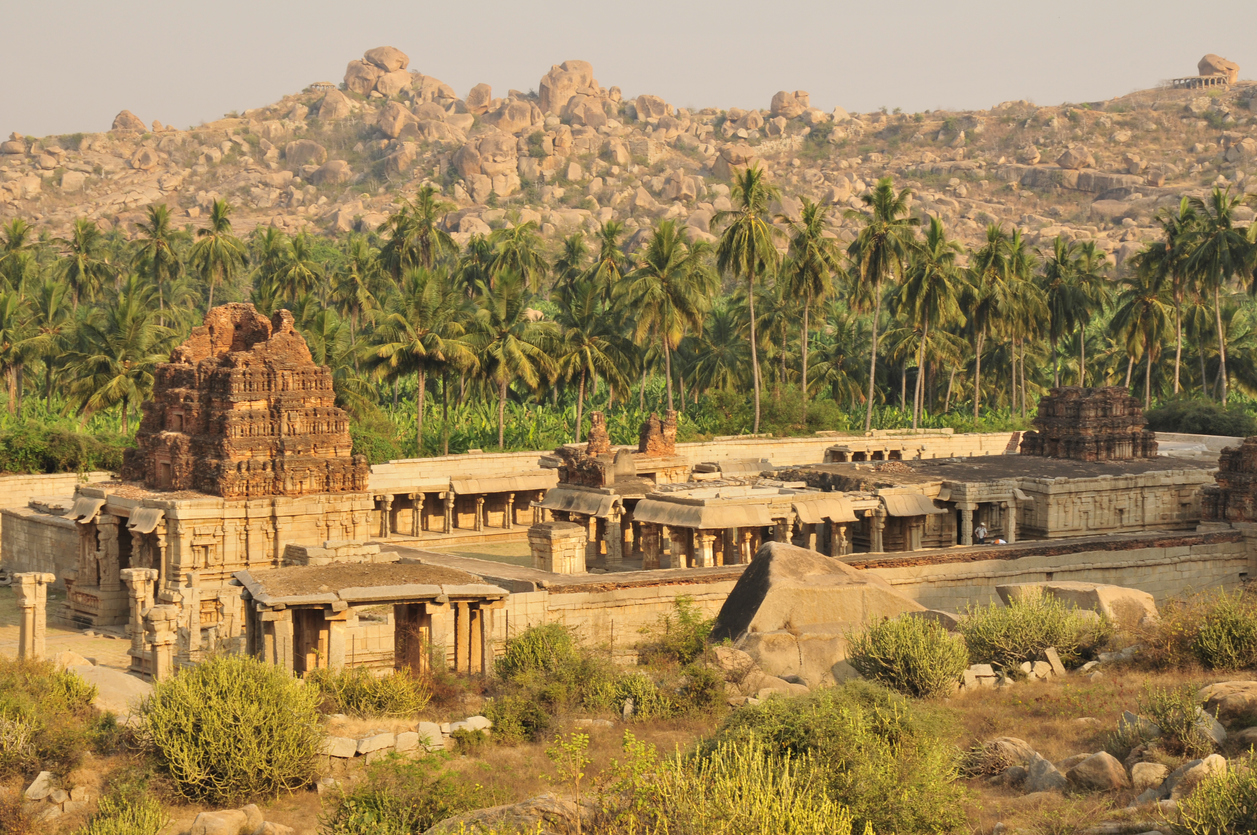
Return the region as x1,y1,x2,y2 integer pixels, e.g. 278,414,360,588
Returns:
0,329,1257,677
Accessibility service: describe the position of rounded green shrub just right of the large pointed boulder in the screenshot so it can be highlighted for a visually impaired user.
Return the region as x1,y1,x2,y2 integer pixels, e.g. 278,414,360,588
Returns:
847,615,969,697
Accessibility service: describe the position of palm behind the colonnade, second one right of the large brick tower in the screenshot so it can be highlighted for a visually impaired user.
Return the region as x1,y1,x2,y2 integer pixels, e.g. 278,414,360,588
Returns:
470,272,557,449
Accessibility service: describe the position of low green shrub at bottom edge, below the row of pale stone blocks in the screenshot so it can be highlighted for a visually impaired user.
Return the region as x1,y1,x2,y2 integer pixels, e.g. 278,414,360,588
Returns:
319,754,489,835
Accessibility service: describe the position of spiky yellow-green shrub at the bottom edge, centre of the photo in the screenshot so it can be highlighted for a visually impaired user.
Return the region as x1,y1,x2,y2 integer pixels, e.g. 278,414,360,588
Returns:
598,734,864,835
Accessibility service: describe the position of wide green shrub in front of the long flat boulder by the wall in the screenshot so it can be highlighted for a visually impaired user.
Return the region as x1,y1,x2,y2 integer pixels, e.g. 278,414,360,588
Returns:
958,595,1112,674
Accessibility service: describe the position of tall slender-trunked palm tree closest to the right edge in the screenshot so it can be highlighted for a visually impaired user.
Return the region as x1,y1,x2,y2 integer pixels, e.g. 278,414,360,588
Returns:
1184,186,1252,406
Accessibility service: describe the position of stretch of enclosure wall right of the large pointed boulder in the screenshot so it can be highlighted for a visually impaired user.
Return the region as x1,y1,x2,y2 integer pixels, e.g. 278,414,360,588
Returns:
847,531,1257,612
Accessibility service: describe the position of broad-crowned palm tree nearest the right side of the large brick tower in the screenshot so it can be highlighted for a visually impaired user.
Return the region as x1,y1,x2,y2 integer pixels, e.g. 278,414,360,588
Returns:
367,268,475,455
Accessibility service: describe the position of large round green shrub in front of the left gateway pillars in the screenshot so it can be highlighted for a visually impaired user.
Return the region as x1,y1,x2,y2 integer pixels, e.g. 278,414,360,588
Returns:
140,655,323,804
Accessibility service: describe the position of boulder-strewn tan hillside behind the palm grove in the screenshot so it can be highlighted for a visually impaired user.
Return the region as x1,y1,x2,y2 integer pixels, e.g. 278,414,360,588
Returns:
0,47,1257,262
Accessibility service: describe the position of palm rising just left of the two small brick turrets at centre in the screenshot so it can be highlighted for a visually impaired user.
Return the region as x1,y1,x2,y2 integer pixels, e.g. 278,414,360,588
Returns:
554,278,632,443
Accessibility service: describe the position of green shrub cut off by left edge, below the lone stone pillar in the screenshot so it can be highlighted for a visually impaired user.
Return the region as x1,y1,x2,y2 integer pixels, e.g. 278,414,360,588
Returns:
0,658,97,777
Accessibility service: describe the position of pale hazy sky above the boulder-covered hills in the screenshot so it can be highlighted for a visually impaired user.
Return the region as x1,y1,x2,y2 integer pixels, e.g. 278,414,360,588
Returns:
7,0,1257,136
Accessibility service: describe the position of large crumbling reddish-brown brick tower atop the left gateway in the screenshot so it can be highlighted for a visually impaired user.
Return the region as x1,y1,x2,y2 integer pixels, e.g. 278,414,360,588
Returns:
122,304,368,499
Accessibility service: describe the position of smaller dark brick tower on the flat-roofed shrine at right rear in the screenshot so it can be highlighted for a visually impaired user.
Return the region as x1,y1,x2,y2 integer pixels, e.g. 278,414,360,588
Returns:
1021,386,1156,462
